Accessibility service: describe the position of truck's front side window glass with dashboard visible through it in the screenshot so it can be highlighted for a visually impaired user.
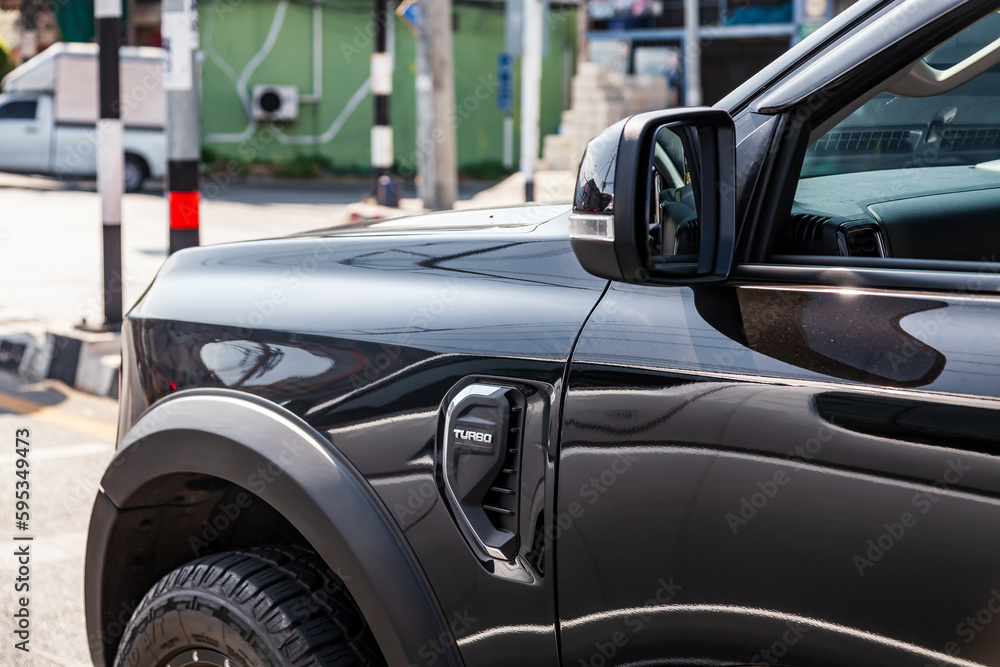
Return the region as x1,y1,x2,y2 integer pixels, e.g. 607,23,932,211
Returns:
772,13,1000,262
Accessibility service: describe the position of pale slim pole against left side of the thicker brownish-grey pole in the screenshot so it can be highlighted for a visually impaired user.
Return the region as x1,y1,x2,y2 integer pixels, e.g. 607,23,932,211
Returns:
414,0,442,210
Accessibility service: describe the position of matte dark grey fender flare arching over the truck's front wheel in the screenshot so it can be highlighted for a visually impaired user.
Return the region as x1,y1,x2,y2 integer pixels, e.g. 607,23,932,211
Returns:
85,389,462,667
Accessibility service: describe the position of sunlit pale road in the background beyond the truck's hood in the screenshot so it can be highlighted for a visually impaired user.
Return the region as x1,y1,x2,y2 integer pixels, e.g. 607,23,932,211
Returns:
0,174,368,325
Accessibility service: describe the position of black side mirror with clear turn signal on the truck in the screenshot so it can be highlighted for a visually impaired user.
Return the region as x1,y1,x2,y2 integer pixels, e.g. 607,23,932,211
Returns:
569,108,736,285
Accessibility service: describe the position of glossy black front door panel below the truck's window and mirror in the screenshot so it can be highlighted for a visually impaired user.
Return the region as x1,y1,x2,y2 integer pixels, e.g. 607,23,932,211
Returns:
556,286,1000,667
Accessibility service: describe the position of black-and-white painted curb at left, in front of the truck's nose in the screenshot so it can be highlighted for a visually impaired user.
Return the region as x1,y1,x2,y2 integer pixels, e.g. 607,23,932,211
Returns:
0,323,121,399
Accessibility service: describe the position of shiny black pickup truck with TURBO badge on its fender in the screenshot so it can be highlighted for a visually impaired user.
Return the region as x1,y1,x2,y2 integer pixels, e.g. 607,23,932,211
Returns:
86,0,1000,667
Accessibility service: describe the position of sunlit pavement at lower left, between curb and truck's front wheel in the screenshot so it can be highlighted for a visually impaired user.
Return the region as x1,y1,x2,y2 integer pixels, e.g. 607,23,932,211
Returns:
0,372,117,667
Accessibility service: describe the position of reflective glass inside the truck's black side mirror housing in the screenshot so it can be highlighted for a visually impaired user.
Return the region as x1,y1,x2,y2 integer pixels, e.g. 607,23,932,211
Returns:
647,123,701,265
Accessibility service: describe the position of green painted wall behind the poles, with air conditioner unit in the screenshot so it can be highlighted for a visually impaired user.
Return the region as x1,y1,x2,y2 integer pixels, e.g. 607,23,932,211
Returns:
200,0,576,172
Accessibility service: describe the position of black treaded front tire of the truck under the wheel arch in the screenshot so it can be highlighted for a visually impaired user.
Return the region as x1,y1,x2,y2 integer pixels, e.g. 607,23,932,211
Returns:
115,546,385,667
